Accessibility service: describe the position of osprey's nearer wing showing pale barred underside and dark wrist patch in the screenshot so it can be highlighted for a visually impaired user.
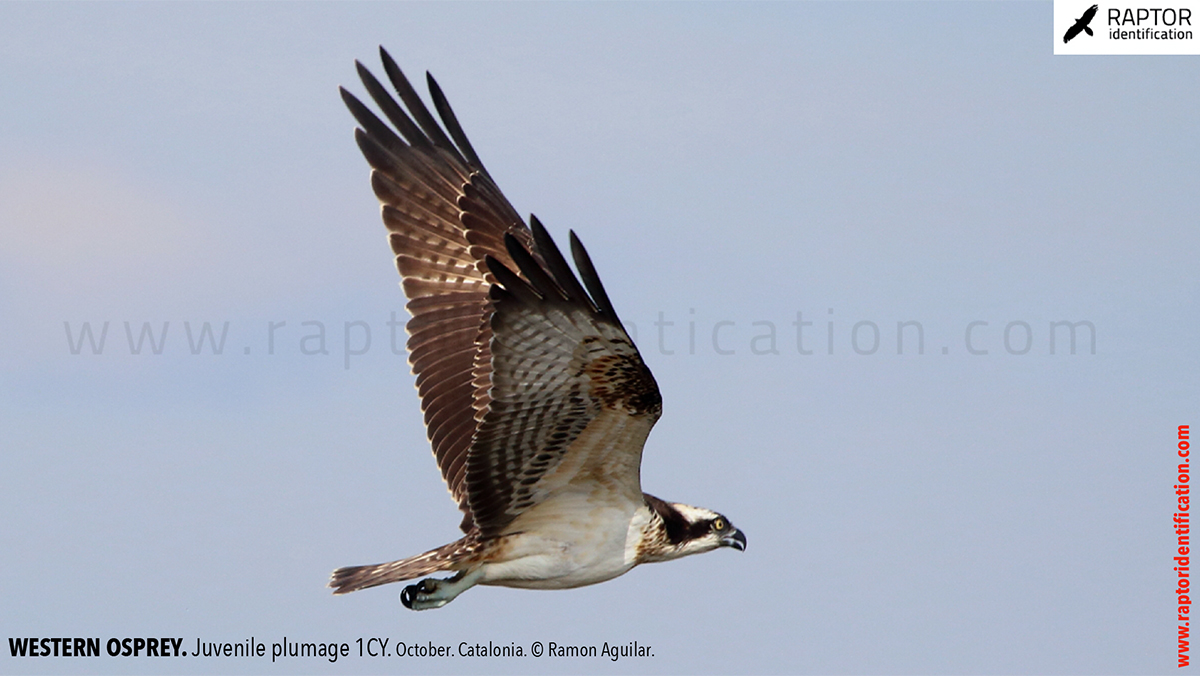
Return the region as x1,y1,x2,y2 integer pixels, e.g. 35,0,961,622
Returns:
467,224,662,538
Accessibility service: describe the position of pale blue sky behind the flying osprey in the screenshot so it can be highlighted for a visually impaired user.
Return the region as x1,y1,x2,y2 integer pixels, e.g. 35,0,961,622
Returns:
0,2,1200,674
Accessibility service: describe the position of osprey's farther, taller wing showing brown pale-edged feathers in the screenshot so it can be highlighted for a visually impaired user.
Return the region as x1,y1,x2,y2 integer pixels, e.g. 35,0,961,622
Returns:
341,47,533,531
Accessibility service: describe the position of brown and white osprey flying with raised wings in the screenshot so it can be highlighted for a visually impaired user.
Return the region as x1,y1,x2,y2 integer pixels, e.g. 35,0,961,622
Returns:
329,48,746,610
